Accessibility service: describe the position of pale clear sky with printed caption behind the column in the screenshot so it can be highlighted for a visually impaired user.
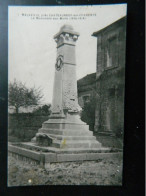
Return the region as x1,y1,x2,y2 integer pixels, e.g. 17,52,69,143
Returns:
8,4,127,103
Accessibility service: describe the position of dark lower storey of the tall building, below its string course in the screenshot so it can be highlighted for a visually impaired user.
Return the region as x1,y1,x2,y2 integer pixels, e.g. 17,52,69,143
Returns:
95,66,124,134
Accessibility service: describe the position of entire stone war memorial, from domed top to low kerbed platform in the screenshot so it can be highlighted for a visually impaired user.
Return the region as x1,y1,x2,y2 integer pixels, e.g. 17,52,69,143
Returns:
8,25,110,168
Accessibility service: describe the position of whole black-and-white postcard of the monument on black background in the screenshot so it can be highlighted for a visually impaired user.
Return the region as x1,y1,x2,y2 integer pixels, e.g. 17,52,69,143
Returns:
7,3,127,187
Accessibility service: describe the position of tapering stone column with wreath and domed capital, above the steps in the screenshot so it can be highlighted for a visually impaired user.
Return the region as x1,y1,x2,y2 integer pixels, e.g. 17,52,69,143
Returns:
52,25,80,118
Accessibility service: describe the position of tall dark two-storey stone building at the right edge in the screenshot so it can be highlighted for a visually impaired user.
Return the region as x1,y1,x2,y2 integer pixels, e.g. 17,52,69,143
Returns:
93,17,126,138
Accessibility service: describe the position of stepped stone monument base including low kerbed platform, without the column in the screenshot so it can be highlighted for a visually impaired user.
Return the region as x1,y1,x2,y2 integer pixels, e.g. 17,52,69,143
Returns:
8,114,122,168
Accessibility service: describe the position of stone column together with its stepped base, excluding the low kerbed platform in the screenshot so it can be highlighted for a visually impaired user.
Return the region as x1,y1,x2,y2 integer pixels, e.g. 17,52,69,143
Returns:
36,25,101,149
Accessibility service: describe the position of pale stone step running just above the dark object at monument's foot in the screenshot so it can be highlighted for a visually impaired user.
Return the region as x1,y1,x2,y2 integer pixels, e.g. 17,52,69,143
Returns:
38,128,93,136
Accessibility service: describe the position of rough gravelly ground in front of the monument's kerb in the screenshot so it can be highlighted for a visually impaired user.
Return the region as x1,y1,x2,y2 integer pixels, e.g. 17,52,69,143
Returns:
8,157,122,186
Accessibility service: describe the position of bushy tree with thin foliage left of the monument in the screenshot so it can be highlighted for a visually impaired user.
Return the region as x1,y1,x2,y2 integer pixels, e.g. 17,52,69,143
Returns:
8,79,43,113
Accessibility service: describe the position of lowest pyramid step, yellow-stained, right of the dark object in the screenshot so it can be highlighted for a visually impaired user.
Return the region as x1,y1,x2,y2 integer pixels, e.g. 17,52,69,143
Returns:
52,140,101,149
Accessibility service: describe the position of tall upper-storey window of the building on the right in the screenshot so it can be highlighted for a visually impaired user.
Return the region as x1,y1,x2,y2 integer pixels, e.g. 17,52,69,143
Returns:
107,37,118,67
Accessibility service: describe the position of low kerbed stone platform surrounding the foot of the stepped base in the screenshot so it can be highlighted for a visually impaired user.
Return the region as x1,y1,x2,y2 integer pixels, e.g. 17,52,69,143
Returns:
8,142,123,169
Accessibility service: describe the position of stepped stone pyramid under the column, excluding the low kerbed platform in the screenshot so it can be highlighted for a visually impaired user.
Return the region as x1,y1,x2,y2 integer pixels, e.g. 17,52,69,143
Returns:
32,113,101,149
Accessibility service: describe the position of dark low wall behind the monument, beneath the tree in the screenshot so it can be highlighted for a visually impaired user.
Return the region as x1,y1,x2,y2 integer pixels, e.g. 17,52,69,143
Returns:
8,113,49,141
